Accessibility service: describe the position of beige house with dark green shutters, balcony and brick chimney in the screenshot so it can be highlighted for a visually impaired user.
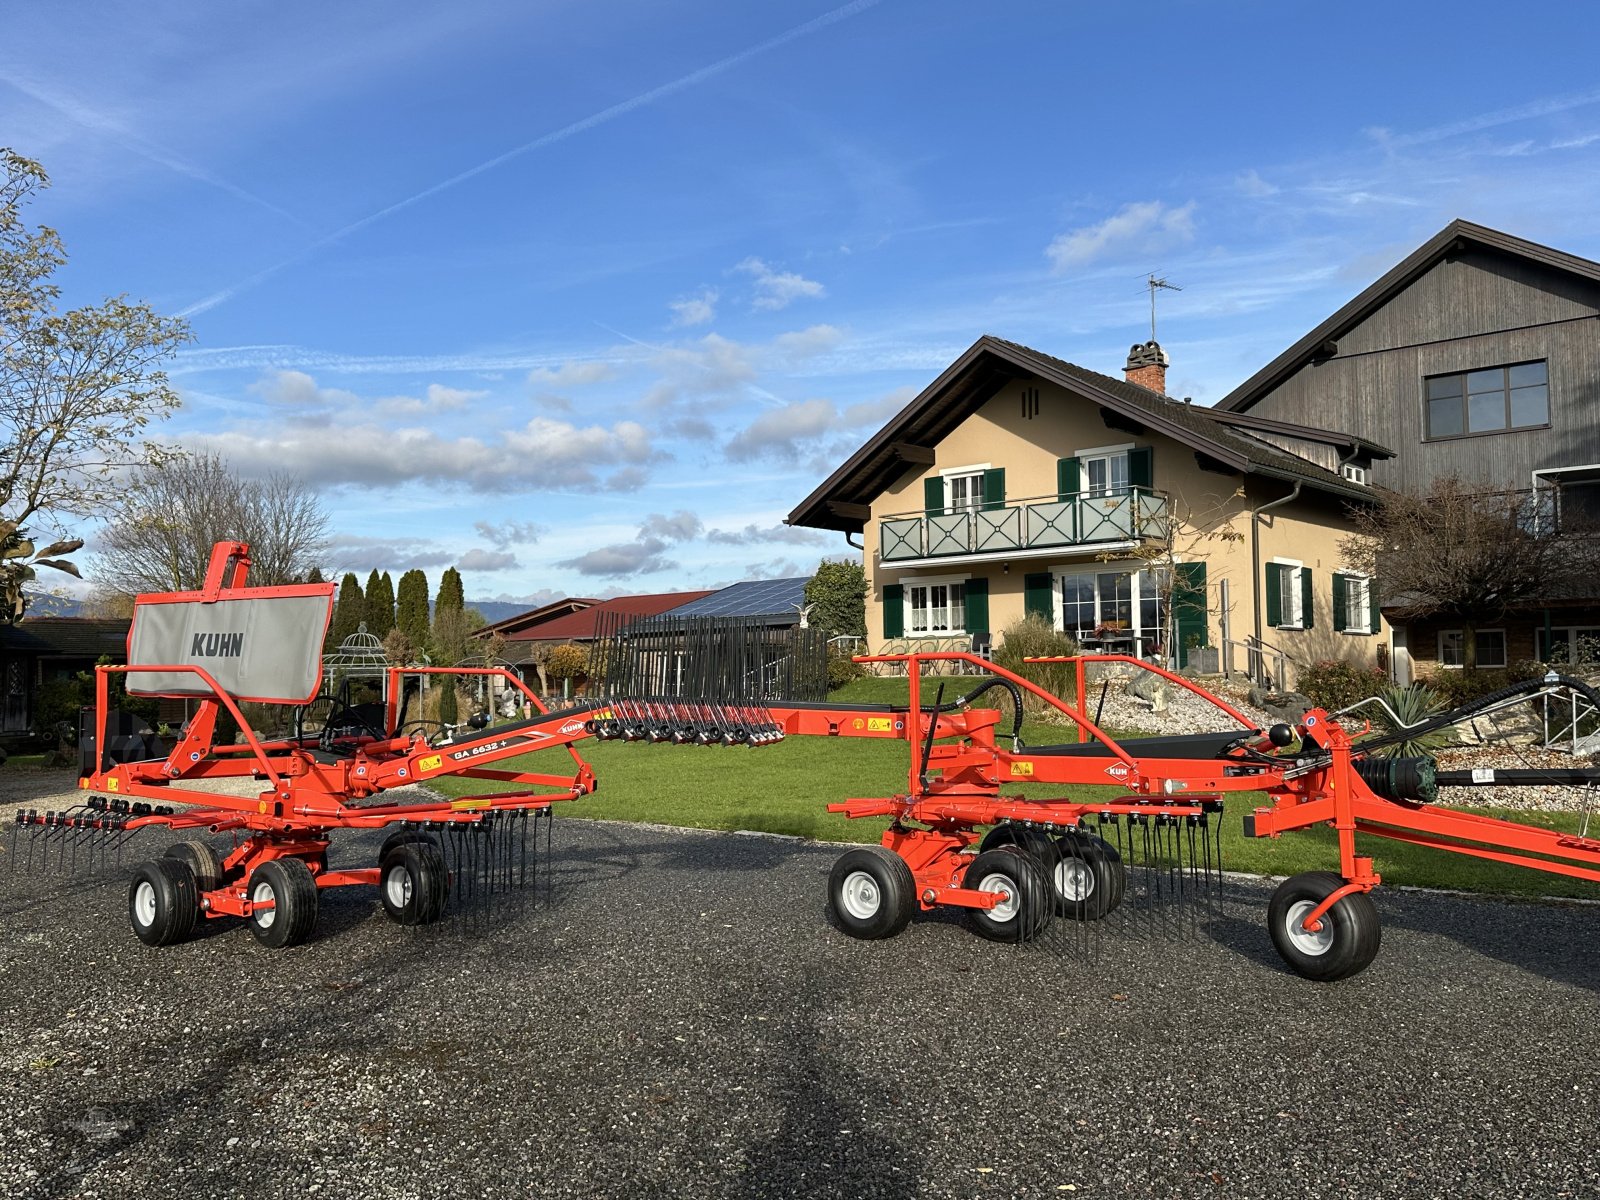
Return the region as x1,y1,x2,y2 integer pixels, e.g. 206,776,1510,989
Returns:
787,336,1392,682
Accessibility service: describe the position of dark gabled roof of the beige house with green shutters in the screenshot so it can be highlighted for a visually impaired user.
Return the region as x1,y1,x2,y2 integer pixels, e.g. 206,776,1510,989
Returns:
787,333,1389,533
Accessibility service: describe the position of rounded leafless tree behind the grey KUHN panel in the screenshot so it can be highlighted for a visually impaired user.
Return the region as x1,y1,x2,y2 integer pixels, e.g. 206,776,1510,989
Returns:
94,454,328,595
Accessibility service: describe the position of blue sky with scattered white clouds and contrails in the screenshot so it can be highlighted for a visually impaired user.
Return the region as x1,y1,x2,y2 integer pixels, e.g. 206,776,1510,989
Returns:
9,0,1600,603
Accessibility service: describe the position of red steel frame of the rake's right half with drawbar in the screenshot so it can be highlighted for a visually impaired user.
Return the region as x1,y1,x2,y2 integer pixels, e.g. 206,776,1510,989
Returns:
773,653,1600,930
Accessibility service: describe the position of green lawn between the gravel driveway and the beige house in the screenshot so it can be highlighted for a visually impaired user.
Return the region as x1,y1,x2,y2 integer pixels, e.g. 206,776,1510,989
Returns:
432,678,1600,899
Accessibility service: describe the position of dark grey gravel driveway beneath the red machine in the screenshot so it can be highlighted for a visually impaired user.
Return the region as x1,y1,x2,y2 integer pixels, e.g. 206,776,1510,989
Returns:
0,803,1600,1198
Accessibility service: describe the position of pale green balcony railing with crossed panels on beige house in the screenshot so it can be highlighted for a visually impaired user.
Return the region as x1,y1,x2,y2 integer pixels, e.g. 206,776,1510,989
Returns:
878,488,1171,563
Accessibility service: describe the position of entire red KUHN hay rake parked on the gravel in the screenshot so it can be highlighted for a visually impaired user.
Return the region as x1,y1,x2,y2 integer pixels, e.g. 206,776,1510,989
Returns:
11,542,1600,981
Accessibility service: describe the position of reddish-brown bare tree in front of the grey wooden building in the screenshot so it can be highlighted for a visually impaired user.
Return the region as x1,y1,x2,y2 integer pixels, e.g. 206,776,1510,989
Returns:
1342,477,1600,667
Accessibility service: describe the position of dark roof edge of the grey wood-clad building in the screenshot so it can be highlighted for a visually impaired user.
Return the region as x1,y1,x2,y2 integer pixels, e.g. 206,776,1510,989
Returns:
1216,219,1600,413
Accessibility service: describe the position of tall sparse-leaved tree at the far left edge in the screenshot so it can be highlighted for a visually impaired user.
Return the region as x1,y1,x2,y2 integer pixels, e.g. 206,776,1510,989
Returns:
0,147,189,621
